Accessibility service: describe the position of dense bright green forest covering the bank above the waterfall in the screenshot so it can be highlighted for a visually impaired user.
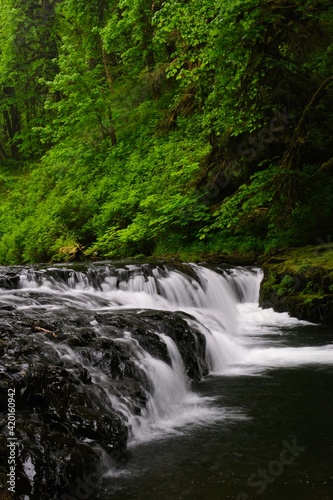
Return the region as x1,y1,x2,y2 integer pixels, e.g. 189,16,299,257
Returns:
0,0,333,264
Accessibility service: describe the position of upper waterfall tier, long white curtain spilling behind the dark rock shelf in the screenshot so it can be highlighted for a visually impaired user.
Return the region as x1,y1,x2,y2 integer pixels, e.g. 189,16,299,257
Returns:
14,264,262,372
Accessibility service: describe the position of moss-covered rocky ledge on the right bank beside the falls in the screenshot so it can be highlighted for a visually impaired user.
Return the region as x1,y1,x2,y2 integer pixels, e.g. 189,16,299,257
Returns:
259,243,333,325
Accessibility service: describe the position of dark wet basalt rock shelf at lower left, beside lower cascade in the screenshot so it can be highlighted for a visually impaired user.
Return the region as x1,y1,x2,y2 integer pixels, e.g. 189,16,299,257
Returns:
0,293,208,500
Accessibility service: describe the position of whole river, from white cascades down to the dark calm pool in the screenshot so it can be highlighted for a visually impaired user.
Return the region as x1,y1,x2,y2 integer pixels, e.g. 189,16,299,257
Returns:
0,263,333,500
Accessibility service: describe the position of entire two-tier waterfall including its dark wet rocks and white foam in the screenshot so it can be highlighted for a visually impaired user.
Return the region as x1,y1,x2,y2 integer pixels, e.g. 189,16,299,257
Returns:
0,263,333,500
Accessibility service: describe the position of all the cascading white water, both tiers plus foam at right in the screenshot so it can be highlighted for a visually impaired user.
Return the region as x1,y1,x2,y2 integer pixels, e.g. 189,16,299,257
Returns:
0,264,333,442
